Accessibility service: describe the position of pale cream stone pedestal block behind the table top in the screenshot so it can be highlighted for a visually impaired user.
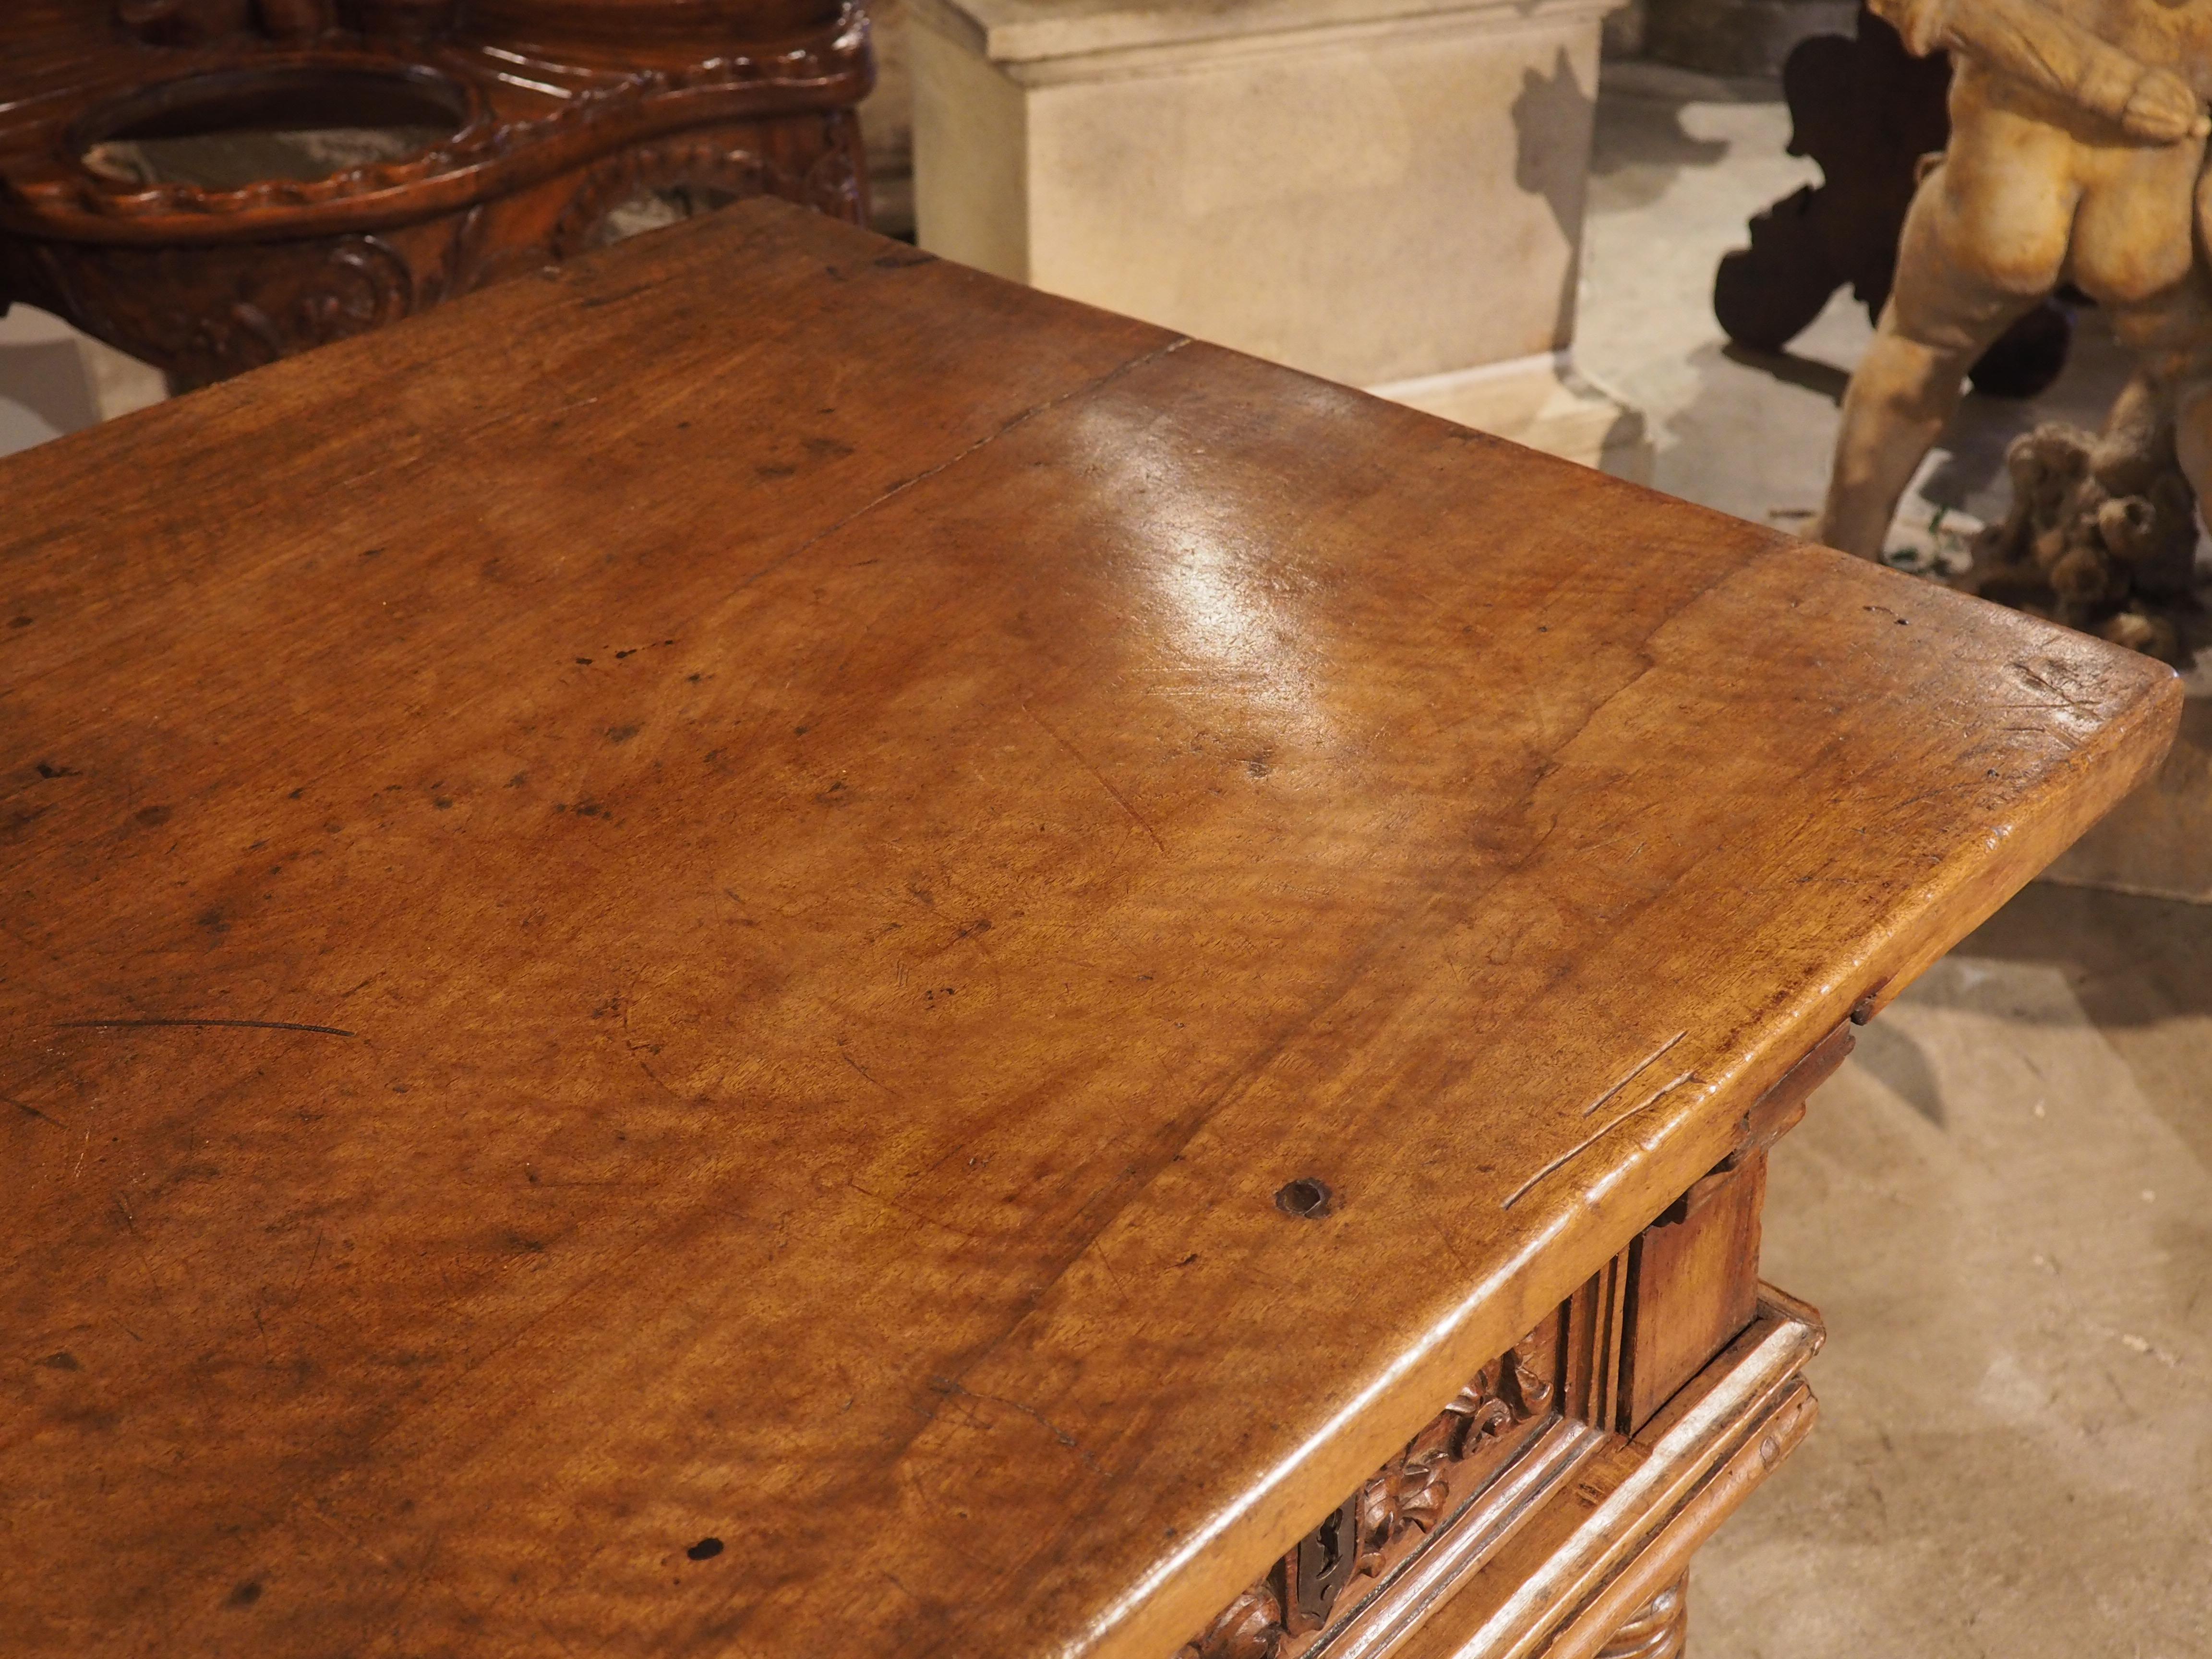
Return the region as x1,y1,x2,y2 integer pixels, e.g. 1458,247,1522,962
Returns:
907,0,1648,476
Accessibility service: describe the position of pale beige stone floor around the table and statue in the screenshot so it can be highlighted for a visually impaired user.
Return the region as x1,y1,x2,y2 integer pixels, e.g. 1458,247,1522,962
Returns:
0,78,2212,1659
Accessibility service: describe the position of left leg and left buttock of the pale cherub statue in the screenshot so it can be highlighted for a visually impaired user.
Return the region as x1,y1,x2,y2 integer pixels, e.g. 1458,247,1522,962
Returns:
1812,135,2073,560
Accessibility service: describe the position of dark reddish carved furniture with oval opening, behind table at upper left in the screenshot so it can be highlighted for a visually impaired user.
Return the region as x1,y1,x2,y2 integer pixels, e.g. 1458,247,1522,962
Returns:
0,0,874,389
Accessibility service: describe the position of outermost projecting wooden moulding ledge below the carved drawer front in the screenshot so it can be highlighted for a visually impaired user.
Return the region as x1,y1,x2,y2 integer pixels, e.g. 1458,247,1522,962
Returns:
1424,1305,1823,1659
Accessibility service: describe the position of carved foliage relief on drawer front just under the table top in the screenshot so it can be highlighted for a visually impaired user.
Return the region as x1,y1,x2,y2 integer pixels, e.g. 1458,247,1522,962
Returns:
1177,1321,1560,1659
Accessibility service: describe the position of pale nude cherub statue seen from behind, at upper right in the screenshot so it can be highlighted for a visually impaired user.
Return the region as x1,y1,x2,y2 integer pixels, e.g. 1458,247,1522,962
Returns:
1812,0,2212,606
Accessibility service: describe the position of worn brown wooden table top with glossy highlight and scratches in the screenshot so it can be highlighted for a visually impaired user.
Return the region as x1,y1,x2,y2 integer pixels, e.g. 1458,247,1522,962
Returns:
0,204,2179,1659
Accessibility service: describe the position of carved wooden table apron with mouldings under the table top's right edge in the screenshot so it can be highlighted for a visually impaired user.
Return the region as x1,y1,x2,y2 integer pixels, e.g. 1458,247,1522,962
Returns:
1179,1024,1854,1659
